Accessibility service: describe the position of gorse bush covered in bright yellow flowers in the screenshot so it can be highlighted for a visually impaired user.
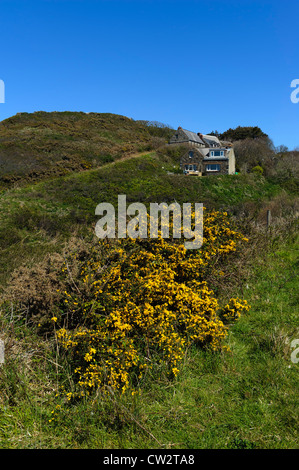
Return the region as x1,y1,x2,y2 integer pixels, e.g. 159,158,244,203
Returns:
52,211,248,393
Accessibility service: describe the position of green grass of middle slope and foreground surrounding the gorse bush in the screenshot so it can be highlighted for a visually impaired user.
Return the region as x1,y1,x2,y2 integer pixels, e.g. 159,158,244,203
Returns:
0,142,299,449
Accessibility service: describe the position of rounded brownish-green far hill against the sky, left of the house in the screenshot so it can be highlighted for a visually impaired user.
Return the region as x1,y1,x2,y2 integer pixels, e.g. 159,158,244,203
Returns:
0,112,172,188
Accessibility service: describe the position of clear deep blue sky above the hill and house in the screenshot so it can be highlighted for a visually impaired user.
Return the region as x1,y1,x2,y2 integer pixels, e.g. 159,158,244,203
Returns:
0,0,299,149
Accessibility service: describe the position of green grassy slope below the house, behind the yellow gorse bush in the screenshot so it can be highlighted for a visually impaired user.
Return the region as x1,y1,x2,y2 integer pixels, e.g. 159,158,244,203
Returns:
0,152,290,287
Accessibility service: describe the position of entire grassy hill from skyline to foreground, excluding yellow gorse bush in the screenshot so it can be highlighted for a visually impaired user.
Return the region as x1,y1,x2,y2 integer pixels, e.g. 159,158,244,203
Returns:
0,113,299,449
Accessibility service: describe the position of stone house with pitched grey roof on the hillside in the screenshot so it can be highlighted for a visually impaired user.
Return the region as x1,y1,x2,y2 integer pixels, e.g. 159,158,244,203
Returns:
169,127,235,176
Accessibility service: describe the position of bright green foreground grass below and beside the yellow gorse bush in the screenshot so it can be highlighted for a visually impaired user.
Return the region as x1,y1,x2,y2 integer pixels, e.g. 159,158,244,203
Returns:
0,231,299,449
